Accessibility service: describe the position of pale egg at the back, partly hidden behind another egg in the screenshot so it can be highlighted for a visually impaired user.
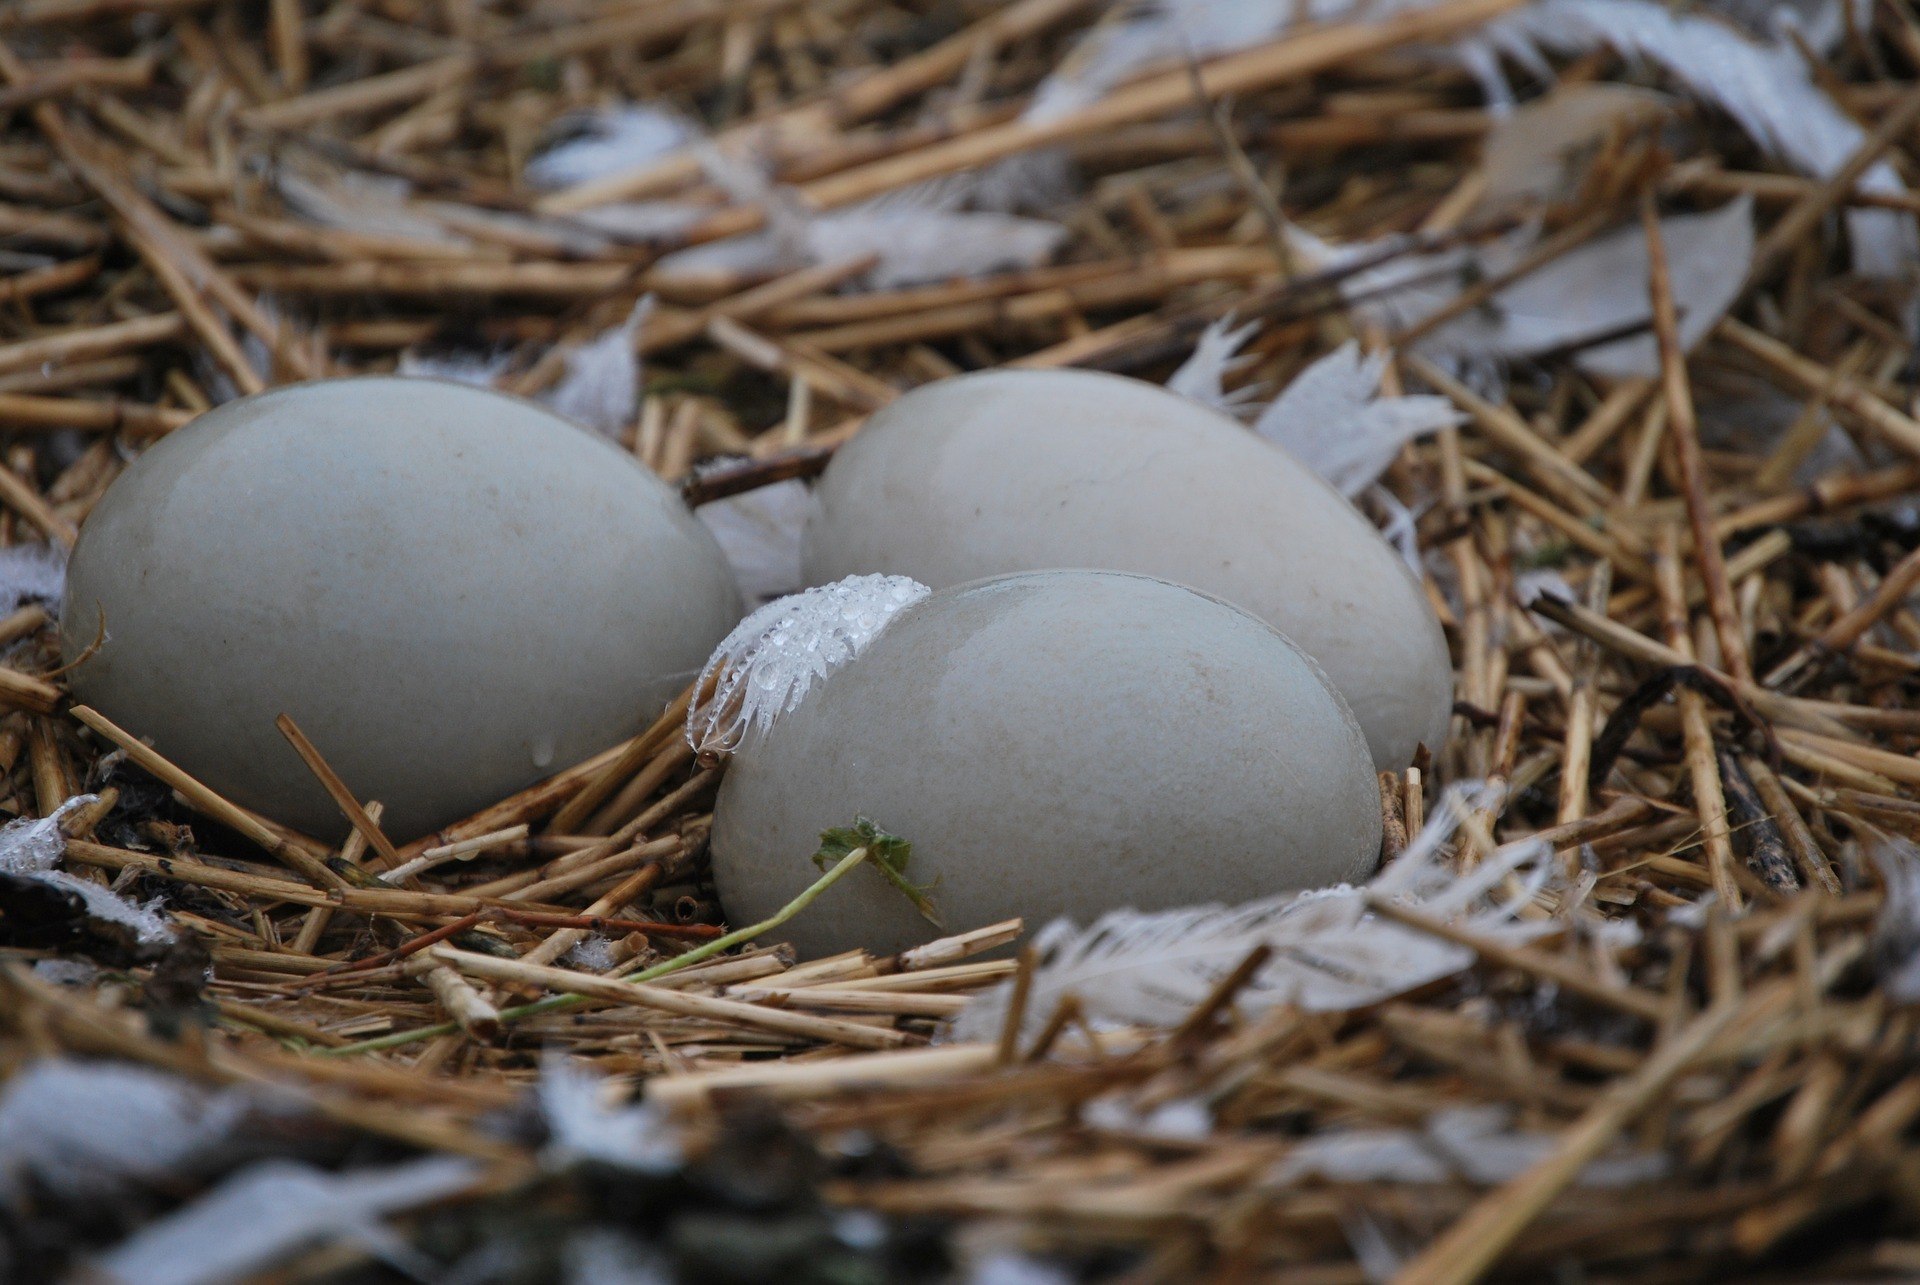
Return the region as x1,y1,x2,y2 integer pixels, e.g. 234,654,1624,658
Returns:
803,371,1453,770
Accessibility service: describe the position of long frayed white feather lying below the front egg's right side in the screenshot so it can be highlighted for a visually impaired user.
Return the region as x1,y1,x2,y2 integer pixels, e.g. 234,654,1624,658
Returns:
950,786,1553,1039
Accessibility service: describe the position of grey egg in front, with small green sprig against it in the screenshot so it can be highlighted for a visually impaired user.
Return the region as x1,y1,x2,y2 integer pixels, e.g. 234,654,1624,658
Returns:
712,570,1380,958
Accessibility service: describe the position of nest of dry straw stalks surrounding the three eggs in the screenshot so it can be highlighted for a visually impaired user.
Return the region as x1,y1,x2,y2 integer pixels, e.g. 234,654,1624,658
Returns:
0,0,1920,1283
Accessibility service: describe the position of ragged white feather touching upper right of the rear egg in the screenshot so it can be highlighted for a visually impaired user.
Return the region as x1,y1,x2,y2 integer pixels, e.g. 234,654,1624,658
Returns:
1254,340,1463,497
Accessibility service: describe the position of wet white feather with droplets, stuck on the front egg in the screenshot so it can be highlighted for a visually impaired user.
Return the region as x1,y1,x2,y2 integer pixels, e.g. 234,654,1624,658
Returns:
687,576,931,755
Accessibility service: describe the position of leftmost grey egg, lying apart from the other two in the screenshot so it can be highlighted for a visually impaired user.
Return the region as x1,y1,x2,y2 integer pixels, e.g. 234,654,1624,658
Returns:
61,378,741,841
